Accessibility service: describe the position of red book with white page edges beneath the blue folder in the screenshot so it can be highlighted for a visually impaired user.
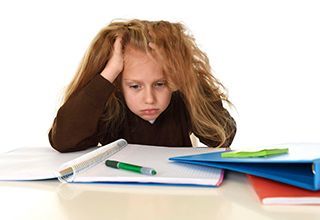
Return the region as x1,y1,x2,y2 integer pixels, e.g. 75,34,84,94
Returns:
247,175,320,205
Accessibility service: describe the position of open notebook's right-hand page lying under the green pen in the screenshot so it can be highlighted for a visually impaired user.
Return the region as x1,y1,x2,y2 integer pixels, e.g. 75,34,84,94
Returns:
74,144,223,185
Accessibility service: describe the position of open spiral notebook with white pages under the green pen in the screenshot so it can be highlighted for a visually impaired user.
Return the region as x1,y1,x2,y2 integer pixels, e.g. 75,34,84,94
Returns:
0,139,223,186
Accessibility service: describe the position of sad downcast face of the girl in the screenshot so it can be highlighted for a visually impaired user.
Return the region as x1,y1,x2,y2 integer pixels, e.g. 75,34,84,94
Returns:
121,46,172,122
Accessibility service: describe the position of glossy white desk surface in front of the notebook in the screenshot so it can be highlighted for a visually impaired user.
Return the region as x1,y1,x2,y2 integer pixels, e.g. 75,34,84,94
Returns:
0,172,320,220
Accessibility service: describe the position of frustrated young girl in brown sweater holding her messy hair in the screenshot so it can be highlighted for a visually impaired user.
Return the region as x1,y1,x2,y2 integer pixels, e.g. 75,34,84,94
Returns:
49,20,236,152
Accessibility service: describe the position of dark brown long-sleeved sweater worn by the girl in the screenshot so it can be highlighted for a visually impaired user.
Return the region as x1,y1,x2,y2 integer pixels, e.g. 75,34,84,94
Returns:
49,75,236,152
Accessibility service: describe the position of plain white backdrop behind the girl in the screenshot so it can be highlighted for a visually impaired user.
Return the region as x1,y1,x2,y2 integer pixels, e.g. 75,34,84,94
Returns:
0,0,320,152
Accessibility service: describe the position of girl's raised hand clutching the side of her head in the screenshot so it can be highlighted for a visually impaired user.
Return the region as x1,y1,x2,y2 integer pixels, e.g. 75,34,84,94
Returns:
100,37,123,82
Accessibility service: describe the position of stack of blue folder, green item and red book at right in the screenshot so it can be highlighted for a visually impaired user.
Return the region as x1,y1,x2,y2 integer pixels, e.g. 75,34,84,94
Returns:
170,143,320,205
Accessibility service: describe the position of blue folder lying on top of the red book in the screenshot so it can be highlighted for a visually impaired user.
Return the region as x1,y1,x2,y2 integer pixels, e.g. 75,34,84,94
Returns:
169,144,320,191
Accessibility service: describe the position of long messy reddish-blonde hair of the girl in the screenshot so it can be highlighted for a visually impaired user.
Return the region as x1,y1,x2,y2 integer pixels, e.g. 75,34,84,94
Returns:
64,19,234,146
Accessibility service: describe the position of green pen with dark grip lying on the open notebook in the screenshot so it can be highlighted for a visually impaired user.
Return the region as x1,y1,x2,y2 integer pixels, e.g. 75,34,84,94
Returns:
105,160,157,175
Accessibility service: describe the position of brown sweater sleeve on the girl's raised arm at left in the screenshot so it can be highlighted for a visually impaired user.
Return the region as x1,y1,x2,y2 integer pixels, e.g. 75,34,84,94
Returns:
49,74,115,152
